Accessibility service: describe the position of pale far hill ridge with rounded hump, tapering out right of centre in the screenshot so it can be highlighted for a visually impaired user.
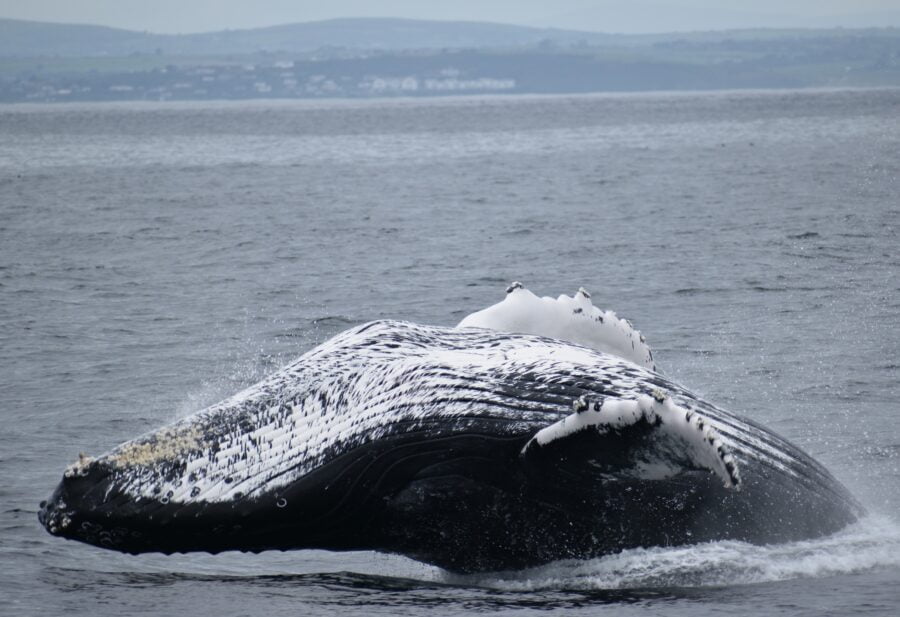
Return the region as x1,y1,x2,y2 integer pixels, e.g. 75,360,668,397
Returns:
0,18,622,57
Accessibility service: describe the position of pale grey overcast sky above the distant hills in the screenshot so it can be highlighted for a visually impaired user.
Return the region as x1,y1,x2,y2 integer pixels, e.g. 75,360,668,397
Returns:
0,0,900,33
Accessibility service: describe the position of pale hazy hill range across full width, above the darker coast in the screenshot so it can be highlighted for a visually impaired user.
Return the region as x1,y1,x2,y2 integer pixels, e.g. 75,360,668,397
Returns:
7,18,898,58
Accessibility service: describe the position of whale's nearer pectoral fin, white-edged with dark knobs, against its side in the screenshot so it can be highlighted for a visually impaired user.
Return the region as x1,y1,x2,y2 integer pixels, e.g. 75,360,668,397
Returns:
521,391,741,490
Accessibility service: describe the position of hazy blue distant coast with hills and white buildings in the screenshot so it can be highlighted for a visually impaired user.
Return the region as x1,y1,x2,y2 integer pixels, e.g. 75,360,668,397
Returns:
0,19,900,103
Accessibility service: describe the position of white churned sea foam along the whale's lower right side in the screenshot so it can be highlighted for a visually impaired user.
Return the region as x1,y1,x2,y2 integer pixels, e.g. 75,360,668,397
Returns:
454,516,900,591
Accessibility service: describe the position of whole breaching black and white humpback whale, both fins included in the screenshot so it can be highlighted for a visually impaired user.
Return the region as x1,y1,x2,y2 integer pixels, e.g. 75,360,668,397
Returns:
39,284,862,572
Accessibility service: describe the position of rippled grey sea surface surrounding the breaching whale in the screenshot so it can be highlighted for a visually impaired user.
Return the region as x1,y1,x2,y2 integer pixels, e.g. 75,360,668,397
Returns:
0,90,900,617
